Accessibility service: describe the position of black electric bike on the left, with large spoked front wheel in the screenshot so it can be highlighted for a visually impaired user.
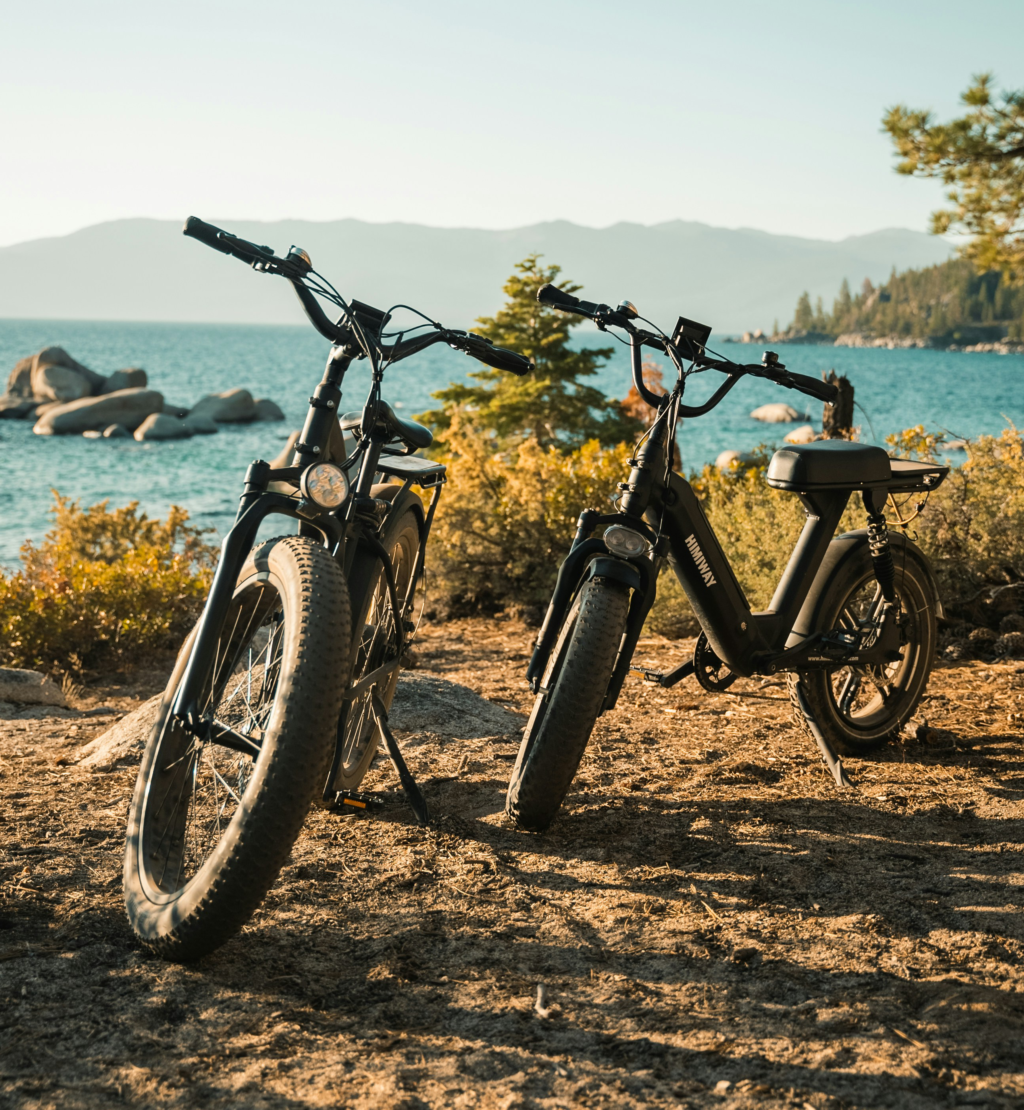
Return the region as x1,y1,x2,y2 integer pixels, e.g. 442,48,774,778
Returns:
124,216,533,960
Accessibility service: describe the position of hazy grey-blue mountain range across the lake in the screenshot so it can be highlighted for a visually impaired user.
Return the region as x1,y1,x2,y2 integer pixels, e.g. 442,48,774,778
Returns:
0,213,950,334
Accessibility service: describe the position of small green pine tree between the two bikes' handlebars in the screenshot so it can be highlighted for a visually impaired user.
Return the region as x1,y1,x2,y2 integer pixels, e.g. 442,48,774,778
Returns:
420,254,643,451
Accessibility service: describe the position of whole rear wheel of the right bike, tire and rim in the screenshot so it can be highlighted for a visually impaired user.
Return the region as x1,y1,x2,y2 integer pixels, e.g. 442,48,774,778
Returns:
789,545,939,756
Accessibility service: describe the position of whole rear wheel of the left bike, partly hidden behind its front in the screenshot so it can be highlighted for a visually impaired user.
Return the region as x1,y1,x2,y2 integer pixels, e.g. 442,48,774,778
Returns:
332,507,419,790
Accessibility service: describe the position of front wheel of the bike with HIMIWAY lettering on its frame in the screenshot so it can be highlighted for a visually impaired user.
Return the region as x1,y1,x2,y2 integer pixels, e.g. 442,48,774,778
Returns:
505,578,629,833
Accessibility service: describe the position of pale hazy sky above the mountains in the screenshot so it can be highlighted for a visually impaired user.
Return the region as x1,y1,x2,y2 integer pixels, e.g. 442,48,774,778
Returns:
0,0,1024,244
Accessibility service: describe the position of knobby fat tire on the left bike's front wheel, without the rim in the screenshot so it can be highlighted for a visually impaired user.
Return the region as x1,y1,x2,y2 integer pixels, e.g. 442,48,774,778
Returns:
124,536,351,961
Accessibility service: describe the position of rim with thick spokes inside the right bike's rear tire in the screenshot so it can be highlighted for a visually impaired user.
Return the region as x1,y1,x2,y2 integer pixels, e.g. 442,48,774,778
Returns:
828,575,923,733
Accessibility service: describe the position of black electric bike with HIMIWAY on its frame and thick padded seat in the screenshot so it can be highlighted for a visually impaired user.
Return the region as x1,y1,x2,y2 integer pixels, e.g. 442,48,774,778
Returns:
506,285,949,830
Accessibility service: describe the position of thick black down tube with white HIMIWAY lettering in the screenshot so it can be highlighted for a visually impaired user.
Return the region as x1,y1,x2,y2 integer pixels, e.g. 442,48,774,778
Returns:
651,473,764,675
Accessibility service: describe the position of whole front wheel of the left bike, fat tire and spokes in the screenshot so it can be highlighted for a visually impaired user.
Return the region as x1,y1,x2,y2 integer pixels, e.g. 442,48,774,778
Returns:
124,536,351,960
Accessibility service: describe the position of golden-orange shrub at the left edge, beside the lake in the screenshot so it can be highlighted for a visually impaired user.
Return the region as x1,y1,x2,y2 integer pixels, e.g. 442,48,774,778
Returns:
0,492,216,672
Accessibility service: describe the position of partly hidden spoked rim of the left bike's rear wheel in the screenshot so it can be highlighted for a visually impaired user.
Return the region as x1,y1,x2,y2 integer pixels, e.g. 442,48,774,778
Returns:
341,532,417,775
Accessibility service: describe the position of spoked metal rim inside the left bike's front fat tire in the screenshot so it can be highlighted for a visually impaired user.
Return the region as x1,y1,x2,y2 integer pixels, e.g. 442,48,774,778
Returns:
139,574,285,902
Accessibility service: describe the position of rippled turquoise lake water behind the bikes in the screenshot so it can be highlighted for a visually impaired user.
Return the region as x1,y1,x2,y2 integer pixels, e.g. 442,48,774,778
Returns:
0,320,1024,565
